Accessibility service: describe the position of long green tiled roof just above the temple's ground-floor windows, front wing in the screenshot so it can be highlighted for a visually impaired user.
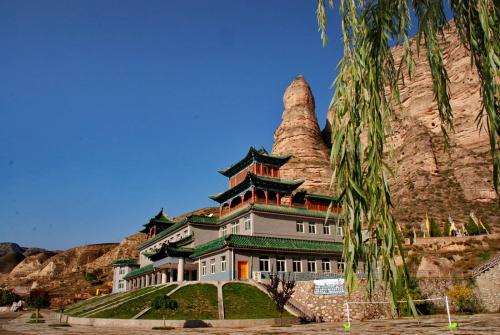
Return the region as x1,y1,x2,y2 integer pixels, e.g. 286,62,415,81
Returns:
191,235,342,258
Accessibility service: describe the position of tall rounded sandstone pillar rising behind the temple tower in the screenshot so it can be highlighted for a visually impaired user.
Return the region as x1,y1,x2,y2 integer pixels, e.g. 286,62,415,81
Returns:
273,76,332,194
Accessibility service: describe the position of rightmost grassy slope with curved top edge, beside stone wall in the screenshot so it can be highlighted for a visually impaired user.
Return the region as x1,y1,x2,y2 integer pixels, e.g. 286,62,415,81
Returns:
222,283,290,319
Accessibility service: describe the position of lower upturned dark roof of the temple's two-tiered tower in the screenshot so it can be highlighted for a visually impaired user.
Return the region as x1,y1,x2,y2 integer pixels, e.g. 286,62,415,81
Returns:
209,172,304,203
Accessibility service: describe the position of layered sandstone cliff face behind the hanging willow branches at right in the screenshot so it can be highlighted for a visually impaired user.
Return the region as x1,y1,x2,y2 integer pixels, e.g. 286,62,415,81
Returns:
323,25,500,229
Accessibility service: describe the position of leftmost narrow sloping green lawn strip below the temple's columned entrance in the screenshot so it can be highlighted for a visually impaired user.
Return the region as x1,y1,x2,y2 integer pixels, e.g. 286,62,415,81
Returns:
90,285,177,319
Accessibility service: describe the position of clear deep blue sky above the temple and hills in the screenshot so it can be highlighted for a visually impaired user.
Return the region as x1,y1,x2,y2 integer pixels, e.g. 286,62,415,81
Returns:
0,0,341,249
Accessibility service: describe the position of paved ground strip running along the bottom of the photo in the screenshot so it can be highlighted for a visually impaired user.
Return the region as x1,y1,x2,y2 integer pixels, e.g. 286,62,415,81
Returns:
0,313,500,335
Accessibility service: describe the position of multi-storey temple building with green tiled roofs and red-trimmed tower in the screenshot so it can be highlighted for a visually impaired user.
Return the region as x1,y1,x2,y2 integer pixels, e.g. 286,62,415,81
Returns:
113,147,343,291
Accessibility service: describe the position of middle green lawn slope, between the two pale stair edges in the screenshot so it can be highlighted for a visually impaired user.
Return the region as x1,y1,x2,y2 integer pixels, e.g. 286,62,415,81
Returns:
140,284,219,320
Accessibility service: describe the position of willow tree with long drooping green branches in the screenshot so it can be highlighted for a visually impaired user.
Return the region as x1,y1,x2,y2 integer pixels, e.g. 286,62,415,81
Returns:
316,0,500,316
